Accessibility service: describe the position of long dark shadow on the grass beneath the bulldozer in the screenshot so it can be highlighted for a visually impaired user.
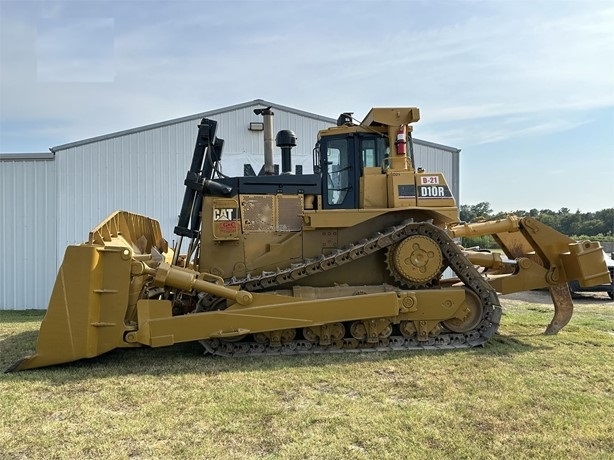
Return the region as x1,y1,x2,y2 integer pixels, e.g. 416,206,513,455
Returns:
0,333,546,385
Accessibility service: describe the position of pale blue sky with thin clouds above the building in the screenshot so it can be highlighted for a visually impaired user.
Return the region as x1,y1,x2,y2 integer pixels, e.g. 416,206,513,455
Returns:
0,0,614,211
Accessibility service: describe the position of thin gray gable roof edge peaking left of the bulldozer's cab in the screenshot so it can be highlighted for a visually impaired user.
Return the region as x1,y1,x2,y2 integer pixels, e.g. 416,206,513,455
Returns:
49,99,337,153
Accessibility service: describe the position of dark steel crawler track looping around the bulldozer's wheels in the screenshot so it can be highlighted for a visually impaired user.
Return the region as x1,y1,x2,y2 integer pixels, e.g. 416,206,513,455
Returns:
201,221,501,356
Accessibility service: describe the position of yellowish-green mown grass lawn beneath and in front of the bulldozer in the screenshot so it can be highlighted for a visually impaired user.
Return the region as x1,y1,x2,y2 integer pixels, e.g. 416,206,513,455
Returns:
0,300,614,459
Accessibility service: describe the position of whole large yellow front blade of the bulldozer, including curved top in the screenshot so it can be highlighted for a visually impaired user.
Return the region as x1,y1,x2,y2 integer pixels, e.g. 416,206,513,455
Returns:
6,211,168,372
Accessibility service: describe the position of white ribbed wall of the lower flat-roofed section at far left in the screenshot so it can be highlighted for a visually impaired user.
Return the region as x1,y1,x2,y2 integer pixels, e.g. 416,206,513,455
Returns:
0,158,58,310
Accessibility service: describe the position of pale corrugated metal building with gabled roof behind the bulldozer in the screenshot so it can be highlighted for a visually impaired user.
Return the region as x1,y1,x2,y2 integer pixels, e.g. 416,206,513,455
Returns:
0,99,460,309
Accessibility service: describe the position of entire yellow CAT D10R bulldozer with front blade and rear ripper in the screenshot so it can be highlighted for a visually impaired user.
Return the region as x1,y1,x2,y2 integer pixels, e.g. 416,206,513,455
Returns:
7,107,610,371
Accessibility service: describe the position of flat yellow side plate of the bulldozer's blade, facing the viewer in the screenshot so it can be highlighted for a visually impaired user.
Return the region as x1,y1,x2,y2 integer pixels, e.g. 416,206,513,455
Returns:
6,245,130,372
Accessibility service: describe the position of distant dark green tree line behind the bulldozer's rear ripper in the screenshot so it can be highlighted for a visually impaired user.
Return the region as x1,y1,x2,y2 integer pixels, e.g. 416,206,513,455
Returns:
459,201,614,247
